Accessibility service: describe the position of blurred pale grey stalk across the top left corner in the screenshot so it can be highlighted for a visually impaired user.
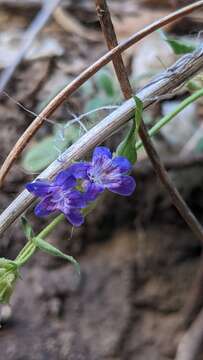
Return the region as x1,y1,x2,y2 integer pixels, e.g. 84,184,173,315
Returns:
0,0,61,94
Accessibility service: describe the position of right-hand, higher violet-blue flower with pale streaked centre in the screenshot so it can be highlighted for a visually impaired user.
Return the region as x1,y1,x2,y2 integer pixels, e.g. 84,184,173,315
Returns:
69,146,136,201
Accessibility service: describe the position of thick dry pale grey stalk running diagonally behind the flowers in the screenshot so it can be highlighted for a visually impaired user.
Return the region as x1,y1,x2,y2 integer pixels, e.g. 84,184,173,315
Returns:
0,46,203,235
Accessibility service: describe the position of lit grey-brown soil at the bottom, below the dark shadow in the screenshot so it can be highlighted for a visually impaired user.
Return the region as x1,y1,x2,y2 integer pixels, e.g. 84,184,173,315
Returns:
1,224,199,360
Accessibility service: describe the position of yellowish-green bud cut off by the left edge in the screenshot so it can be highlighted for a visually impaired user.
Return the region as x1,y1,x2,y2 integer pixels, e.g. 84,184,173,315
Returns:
0,258,19,304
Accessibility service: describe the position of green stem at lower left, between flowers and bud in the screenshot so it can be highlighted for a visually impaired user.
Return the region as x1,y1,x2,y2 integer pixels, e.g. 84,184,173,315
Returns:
15,214,65,267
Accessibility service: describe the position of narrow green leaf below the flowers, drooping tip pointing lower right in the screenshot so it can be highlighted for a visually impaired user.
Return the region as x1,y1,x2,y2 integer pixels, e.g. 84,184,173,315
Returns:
33,237,80,275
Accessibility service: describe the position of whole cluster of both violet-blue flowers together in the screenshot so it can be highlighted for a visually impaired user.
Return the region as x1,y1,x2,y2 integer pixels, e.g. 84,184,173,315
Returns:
26,146,136,226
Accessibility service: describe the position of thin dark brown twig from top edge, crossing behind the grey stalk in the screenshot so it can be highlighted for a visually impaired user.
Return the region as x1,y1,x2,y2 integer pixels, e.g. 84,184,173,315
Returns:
95,0,203,242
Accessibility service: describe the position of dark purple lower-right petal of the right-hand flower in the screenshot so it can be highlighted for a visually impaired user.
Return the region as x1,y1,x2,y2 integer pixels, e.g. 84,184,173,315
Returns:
107,175,136,196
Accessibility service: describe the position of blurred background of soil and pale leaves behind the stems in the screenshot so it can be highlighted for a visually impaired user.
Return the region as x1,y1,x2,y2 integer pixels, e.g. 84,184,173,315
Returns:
0,0,203,360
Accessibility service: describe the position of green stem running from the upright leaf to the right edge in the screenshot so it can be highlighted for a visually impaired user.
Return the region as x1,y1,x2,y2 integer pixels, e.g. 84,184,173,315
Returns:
136,89,203,150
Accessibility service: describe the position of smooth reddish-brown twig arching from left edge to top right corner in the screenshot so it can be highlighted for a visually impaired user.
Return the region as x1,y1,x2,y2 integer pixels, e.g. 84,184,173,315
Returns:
0,0,203,186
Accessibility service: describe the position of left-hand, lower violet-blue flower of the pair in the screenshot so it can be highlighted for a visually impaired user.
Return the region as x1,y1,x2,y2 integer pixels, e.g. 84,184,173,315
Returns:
26,169,86,226
